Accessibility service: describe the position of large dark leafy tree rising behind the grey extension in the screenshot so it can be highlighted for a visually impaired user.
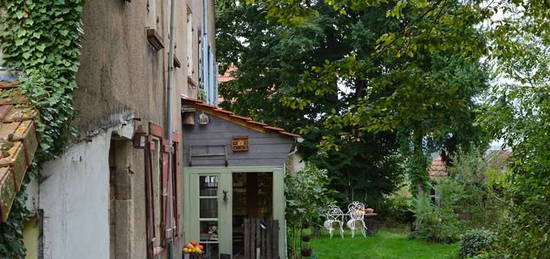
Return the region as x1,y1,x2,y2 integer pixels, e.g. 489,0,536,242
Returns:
217,1,487,201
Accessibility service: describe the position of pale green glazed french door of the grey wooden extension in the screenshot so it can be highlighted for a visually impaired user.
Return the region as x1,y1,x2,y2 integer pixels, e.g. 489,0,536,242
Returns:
183,166,286,259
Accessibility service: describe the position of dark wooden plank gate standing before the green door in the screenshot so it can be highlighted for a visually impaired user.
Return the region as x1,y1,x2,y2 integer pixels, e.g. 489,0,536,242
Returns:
244,219,279,259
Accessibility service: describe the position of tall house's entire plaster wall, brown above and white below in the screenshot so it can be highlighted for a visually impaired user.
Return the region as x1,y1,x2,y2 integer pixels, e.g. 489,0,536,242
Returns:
40,0,215,258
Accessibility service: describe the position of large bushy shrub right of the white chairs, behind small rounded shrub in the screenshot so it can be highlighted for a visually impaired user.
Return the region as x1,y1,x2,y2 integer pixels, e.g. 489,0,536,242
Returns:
412,149,508,245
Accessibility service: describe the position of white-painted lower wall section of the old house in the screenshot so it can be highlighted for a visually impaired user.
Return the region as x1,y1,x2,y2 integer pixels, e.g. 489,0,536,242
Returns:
39,123,133,259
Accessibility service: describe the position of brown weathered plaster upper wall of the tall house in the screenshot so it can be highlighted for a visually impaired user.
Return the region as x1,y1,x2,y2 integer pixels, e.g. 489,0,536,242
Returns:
75,0,203,135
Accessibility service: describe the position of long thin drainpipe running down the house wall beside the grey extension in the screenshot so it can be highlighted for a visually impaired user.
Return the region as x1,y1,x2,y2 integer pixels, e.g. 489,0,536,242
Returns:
165,0,177,259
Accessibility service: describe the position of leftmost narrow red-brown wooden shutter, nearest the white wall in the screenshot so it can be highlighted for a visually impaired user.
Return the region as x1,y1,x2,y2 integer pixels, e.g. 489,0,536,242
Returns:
144,136,155,259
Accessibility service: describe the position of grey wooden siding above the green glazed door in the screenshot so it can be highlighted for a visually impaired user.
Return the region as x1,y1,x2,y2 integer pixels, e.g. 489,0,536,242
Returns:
183,113,295,167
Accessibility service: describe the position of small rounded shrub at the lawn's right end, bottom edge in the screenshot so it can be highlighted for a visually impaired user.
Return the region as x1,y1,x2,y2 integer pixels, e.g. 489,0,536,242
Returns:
458,229,496,258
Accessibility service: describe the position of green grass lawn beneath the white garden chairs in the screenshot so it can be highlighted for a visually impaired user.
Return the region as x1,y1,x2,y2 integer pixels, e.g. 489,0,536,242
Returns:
311,229,458,259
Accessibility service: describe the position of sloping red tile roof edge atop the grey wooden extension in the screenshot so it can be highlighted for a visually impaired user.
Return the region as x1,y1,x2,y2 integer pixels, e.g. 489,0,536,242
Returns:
181,96,300,138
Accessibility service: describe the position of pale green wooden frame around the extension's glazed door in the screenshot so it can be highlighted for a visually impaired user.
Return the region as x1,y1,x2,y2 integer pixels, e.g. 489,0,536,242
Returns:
182,166,286,259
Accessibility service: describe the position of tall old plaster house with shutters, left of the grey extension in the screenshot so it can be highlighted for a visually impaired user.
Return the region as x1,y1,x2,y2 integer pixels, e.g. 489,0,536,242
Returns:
0,0,217,259
